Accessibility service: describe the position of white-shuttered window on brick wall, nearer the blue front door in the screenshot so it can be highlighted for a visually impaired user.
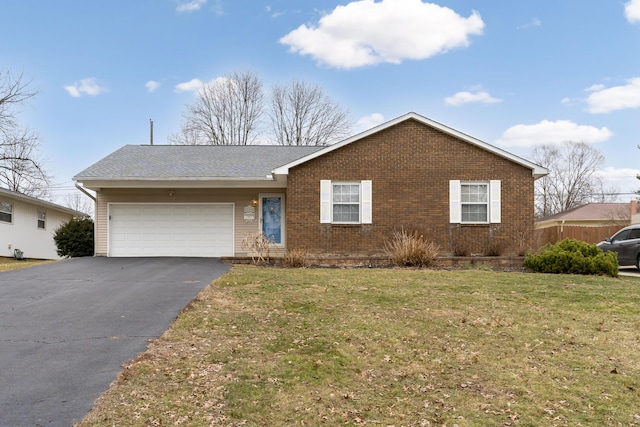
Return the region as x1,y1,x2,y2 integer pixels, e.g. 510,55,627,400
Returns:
320,180,372,224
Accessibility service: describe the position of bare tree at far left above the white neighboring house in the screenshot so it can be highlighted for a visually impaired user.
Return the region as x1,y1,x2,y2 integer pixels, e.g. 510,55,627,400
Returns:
0,127,51,199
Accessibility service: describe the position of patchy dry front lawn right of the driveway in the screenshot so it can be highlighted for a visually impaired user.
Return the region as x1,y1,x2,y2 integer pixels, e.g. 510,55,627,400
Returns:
81,266,640,427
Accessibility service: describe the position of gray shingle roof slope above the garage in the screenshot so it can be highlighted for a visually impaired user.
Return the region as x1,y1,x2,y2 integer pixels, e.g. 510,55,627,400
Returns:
74,145,324,181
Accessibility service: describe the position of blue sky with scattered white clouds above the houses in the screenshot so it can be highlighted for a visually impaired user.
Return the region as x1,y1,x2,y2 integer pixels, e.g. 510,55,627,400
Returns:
0,0,640,204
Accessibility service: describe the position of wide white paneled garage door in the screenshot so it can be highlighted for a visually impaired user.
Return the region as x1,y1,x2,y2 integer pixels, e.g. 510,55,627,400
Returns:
109,203,233,257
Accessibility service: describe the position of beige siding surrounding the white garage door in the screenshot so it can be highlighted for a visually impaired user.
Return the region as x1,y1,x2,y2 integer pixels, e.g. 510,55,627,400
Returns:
95,188,276,256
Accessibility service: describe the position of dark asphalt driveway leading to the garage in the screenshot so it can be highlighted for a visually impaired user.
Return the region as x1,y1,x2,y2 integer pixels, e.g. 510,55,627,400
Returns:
0,257,229,427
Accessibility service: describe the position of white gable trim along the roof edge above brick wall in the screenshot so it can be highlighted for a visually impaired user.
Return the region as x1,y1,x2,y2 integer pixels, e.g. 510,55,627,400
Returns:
273,112,548,178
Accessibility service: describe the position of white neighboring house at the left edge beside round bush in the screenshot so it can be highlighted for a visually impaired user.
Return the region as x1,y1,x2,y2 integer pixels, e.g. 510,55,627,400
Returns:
0,188,85,259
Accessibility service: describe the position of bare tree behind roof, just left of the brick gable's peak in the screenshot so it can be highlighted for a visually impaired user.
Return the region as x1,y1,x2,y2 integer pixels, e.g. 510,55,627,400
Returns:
269,79,351,145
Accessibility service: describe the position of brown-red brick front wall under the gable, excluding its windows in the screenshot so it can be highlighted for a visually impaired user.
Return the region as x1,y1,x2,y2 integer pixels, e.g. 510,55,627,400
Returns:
286,120,534,255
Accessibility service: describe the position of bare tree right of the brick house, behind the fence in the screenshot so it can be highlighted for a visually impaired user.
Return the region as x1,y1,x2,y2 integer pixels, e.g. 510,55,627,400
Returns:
531,141,605,217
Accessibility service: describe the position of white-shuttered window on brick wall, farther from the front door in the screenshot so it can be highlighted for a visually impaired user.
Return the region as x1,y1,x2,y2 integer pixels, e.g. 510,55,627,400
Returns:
449,180,501,224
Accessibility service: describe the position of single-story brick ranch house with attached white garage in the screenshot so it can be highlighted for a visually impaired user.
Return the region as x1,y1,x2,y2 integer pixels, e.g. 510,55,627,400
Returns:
74,113,547,257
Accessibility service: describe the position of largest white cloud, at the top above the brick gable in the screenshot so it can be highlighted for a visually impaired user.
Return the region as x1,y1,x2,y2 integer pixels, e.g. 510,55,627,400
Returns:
280,0,484,68
